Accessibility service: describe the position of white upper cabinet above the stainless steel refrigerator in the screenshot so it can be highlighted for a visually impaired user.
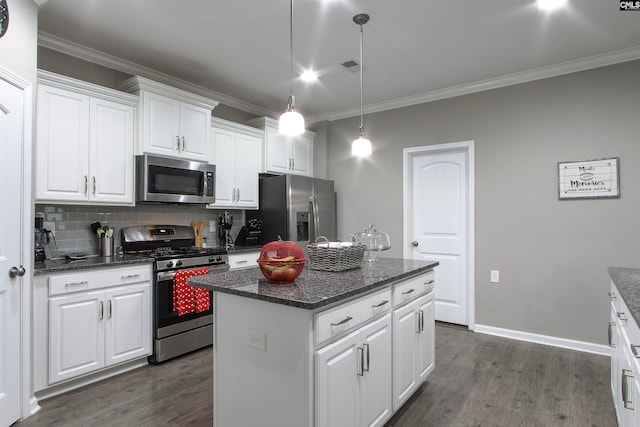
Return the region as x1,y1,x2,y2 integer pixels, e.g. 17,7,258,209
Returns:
247,117,316,176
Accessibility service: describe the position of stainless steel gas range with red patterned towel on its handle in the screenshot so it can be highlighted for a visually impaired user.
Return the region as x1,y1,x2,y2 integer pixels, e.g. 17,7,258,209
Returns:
121,225,229,363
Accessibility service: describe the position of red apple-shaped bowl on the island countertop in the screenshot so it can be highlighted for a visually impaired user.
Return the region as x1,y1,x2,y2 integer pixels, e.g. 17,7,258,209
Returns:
258,240,306,284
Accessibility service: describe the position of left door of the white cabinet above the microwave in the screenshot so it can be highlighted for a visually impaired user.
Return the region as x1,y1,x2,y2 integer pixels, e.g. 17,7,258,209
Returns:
141,92,181,157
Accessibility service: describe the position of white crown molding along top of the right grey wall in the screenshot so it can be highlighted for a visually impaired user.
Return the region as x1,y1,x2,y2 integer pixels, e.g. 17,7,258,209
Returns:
320,46,640,122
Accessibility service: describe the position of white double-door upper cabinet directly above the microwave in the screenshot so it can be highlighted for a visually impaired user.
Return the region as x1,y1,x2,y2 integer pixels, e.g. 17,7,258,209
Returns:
119,76,218,162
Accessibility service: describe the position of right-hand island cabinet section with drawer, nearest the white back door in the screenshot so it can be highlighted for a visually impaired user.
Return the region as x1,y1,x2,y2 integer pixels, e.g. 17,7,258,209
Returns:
393,275,435,410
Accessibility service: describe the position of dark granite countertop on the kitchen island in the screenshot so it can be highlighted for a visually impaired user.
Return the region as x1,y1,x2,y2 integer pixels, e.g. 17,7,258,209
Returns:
187,258,439,310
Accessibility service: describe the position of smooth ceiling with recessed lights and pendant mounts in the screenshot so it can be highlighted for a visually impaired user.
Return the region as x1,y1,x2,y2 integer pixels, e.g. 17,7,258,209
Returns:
38,0,640,120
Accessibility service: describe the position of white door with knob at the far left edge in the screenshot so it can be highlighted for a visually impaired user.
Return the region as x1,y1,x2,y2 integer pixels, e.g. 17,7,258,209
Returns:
0,71,24,426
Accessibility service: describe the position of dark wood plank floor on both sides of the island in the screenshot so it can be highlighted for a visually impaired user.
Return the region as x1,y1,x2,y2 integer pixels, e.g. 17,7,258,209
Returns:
14,324,616,427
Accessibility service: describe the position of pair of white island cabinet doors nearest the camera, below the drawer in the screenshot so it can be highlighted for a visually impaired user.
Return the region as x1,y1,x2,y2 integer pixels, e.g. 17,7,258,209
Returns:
315,314,392,427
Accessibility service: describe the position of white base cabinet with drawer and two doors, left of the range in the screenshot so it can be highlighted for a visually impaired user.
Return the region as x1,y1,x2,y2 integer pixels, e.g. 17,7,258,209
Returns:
34,265,152,391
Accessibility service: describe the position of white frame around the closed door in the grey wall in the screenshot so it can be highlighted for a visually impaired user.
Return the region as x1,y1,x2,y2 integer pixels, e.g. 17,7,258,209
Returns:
402,141,476,331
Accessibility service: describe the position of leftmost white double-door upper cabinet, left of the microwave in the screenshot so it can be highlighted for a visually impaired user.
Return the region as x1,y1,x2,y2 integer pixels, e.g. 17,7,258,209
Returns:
35,71,138,205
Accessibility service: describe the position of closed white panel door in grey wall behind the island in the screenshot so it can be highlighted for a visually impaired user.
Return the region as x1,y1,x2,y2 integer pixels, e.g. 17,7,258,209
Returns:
409,150,470,325
